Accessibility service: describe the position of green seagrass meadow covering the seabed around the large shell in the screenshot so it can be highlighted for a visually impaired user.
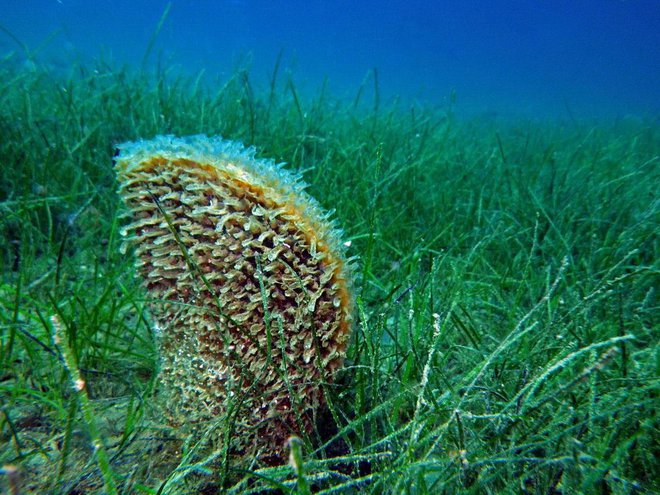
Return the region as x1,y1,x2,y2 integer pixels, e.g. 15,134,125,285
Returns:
0,57,660,495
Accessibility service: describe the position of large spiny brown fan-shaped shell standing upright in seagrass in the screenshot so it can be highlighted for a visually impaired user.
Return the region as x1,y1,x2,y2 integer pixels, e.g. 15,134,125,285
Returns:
115,136,352,459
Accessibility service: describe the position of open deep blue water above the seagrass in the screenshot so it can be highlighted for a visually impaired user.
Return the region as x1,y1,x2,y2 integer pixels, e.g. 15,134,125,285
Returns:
0,0,660,119
